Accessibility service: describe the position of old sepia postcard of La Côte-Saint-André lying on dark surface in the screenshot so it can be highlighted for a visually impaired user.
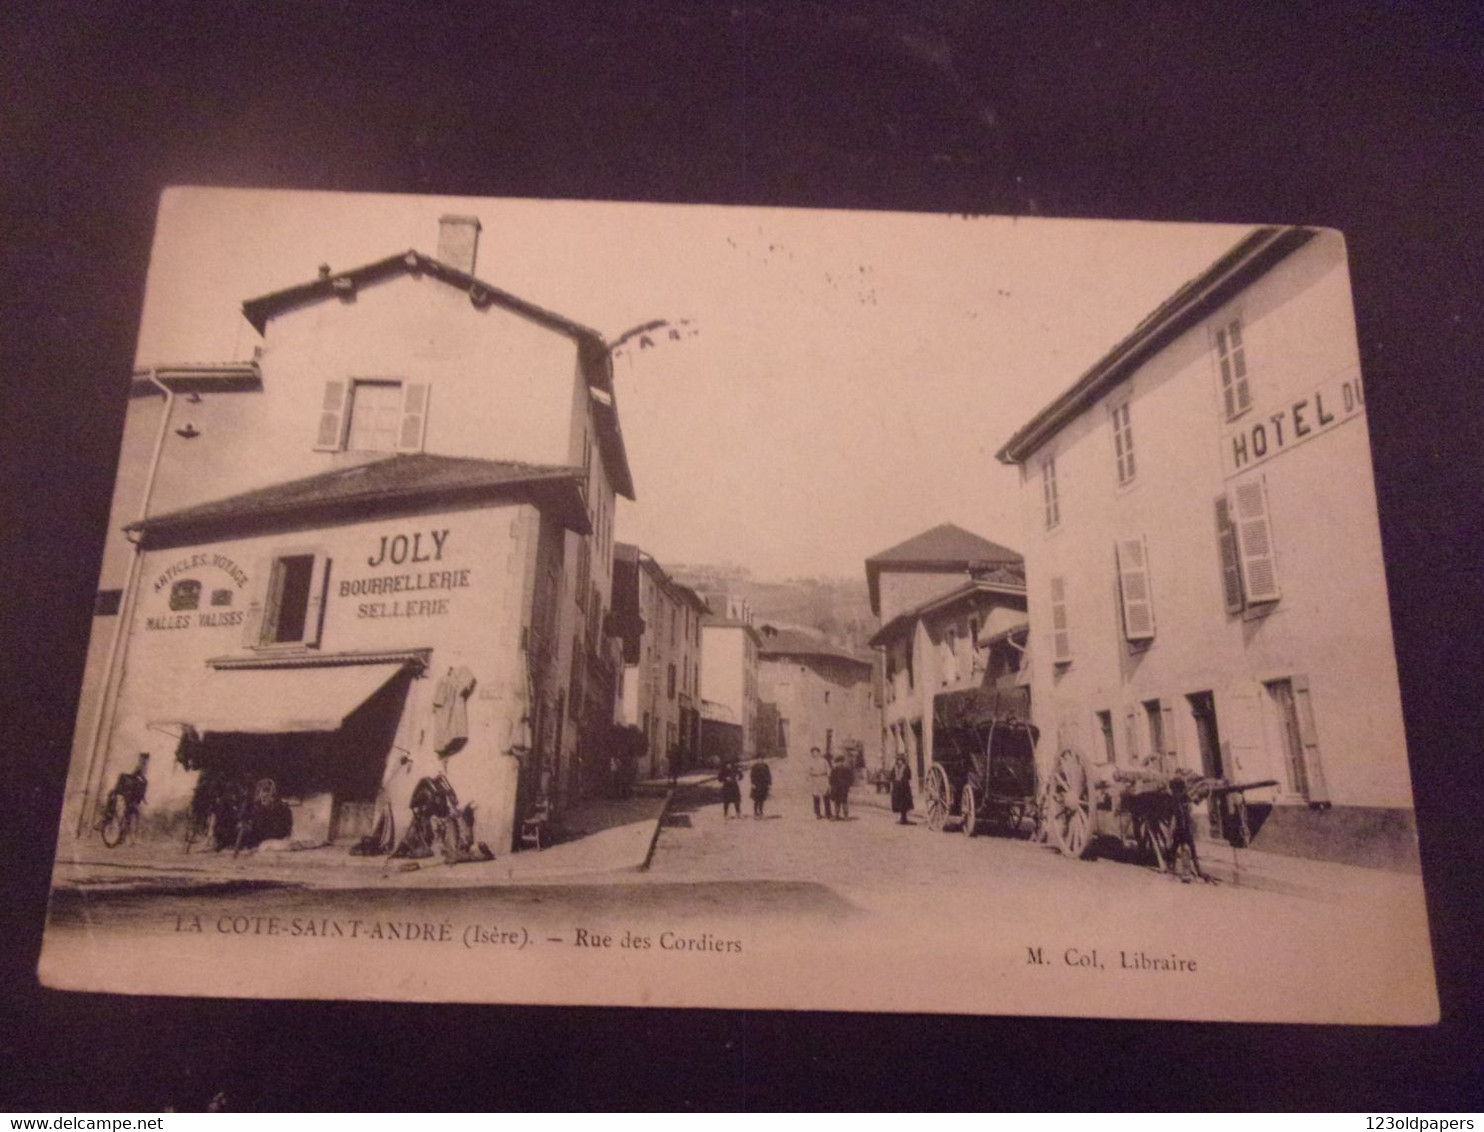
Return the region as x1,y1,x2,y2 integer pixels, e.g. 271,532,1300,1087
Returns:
40,188,1438,1024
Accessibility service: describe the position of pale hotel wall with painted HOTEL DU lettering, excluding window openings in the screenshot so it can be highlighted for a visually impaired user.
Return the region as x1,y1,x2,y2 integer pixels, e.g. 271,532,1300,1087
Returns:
1021,233,1411,807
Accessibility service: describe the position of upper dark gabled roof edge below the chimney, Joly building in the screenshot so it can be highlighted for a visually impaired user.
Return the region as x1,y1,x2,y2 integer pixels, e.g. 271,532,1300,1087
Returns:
242,249,634,498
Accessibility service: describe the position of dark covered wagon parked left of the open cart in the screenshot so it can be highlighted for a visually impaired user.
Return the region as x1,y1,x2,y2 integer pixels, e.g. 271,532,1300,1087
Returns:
923,688,1039,837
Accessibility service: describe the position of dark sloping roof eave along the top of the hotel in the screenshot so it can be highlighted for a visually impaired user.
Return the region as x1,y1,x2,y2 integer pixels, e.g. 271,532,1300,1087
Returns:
996,227,1319,464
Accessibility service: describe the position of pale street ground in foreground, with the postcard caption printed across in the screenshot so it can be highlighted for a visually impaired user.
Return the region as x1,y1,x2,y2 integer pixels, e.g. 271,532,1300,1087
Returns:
42,760,1426,1021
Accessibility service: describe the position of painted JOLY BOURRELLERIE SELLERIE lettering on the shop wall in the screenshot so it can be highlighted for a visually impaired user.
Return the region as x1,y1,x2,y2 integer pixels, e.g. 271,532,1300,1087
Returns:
334,528,469,620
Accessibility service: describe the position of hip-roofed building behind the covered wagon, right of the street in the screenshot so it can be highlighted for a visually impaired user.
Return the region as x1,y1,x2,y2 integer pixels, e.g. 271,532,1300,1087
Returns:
865,524,1025,782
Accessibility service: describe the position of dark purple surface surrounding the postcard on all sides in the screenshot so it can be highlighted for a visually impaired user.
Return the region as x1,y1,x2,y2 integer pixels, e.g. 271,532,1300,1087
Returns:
0,0,1484,1113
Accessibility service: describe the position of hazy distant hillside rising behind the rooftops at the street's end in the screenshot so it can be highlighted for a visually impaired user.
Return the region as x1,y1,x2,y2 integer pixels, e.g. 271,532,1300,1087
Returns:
665,562,880,650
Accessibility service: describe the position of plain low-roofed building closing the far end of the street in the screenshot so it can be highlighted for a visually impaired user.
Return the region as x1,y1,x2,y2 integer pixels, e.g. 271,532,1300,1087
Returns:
757,625,881,769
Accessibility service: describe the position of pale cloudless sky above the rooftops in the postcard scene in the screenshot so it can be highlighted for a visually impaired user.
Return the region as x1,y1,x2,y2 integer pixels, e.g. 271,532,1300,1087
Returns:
137,188,1248,580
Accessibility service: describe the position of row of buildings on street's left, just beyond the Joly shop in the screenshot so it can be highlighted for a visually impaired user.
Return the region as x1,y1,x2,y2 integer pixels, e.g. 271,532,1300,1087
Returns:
613,543,706,777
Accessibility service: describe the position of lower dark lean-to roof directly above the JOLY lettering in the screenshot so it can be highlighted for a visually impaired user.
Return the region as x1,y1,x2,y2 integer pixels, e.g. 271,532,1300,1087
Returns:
123,453,591,547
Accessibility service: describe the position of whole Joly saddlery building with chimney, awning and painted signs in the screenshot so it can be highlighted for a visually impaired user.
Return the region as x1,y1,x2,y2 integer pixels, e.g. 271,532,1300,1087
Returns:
68,217,632,852
